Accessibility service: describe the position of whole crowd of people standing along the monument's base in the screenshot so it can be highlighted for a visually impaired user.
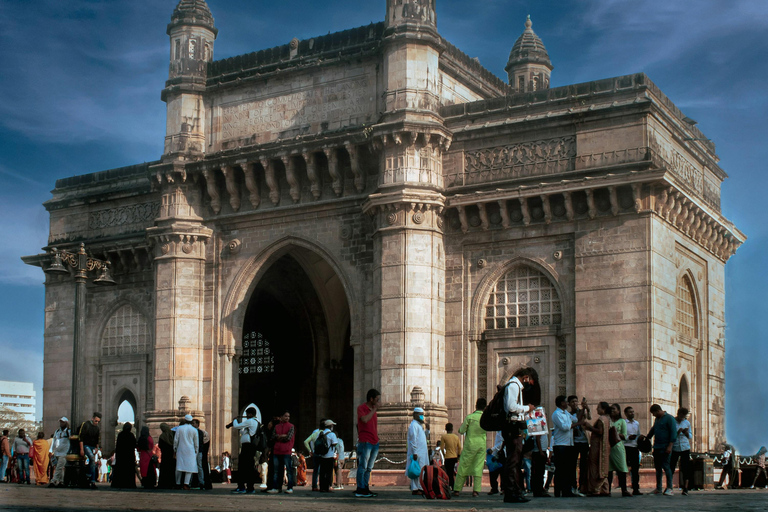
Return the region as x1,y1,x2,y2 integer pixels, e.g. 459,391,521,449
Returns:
0,374,768,503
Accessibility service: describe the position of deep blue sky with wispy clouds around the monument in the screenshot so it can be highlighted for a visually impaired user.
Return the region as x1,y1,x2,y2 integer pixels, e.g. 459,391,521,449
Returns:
0,0,768,452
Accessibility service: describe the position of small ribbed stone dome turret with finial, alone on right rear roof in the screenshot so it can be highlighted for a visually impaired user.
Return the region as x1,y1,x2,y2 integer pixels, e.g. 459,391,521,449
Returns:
504,15,554,92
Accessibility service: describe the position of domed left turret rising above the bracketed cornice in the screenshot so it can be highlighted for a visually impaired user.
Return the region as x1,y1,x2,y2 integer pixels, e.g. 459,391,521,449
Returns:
162,0,218,161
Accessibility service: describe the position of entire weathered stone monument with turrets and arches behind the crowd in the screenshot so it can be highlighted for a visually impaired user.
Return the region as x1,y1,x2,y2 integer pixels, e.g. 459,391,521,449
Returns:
25,0,745,460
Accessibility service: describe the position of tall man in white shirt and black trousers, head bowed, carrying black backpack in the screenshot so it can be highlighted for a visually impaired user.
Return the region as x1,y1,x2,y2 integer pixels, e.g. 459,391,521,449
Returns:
501,368,537,503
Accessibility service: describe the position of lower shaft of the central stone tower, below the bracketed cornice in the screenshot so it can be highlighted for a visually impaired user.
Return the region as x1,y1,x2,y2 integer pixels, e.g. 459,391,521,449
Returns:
364,190,447,460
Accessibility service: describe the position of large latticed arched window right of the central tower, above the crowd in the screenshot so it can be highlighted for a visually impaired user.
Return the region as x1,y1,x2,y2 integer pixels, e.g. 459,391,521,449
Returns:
485,265,562,329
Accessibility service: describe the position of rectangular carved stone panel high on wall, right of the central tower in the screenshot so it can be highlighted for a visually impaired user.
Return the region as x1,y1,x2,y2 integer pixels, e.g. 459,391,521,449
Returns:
464,137,576,184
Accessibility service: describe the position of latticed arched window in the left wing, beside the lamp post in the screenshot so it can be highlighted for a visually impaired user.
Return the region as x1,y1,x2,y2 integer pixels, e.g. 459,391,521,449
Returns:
101,304,150,356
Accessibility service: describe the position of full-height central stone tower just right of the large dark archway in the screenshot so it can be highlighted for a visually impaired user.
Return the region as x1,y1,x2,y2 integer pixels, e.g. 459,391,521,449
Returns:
363,0,451,457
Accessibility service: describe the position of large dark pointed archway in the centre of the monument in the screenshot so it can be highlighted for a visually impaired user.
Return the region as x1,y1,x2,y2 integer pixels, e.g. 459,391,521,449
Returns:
234,252,354,449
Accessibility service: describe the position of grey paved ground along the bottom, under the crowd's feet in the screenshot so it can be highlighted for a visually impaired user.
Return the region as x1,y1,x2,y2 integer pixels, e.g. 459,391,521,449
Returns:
0,484,768,512
